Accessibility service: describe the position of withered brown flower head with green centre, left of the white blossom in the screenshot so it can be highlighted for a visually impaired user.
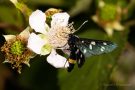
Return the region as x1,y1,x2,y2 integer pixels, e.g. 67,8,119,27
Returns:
1,27,34,73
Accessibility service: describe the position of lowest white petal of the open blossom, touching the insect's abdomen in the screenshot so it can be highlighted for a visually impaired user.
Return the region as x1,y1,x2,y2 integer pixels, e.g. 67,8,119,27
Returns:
47,49,69,68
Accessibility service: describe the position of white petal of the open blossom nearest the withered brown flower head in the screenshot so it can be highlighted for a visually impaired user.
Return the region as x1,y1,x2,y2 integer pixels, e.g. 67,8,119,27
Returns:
27,33,46,54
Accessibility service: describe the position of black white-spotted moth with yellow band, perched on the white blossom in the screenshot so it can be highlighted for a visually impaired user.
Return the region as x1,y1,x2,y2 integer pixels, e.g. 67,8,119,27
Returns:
68,34,117,72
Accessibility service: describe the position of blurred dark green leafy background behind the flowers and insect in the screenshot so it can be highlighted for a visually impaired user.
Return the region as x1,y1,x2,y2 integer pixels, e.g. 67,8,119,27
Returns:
0,0,135,90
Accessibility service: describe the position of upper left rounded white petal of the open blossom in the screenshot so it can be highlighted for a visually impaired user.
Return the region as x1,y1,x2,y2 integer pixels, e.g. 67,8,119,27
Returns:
29,10,46,34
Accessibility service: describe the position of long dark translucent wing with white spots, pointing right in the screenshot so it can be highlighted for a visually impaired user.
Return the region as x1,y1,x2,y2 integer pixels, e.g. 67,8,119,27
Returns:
76,38,117,57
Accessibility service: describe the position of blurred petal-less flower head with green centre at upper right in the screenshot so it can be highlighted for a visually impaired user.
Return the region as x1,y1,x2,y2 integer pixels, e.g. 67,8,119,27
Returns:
92,0,124,36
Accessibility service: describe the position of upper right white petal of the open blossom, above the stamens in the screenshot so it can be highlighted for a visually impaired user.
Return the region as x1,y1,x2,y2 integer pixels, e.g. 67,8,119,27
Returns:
51,12,70,27
